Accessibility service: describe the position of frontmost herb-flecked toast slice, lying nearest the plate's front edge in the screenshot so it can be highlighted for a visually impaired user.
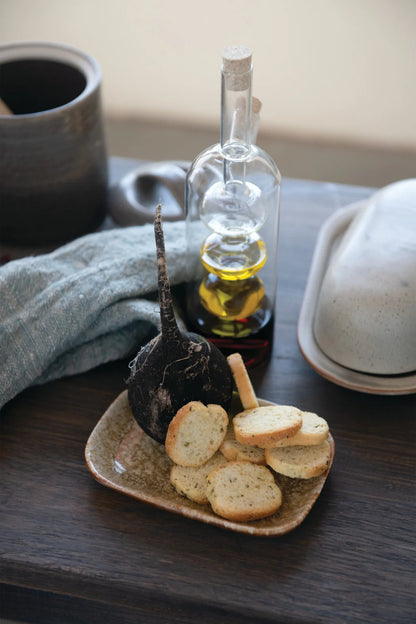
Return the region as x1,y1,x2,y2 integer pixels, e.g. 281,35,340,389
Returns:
207,462,282,522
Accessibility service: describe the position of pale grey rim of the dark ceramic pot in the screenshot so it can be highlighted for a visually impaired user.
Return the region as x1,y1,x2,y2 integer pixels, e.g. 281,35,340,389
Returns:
0,41,101,123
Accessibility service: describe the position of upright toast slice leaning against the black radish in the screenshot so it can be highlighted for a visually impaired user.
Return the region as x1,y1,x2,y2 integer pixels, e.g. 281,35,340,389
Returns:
165,401,229,466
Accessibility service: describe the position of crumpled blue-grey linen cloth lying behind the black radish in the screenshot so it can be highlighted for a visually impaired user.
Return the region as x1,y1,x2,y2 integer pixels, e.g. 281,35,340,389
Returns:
0,221,186,409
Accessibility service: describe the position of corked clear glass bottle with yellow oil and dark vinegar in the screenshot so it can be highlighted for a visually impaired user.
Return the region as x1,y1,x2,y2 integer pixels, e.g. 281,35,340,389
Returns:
185,46,281,366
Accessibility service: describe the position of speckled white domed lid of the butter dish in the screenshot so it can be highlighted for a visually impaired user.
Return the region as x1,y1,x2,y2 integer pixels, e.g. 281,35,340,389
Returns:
314,179,416,375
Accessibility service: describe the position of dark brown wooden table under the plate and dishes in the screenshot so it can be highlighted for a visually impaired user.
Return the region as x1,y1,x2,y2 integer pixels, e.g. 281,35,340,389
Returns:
0,159,416,624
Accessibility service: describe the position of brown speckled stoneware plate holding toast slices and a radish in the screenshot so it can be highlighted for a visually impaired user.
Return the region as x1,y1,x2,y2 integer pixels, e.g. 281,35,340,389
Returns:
85,390,335,536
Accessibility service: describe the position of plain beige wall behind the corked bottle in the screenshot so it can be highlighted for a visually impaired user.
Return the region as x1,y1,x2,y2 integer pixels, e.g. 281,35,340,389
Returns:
0,0,416,150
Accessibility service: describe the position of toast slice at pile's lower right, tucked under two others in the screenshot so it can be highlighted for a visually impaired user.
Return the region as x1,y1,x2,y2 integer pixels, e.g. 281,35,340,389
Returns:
266,440,331,479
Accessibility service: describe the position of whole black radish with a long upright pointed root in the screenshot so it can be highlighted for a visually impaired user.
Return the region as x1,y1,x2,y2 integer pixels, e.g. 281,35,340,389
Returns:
127,205,233,443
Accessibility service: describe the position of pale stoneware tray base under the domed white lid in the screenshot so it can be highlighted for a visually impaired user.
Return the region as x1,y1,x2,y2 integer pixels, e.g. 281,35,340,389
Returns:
298,202,416,395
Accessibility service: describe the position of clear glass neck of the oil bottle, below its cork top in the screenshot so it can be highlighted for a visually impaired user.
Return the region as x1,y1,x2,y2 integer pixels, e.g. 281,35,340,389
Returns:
221,68,252,160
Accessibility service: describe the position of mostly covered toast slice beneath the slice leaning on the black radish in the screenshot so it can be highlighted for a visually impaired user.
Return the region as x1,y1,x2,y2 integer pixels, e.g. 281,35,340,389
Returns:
170,452,227,505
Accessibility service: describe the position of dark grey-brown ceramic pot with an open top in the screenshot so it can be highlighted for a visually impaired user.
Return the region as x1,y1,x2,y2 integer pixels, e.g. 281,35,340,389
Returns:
0,42,108,245
